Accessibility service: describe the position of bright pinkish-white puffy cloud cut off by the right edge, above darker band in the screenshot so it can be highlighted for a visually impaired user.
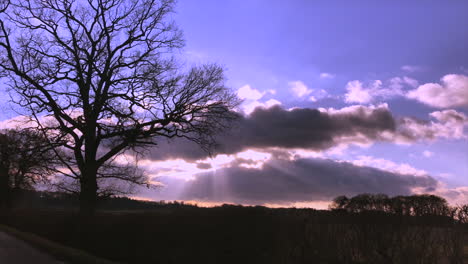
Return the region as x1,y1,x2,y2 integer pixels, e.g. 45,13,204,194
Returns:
407,74,468,108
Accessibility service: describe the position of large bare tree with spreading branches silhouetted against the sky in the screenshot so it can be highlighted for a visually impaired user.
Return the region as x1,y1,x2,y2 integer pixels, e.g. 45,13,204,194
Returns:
0,0,237,214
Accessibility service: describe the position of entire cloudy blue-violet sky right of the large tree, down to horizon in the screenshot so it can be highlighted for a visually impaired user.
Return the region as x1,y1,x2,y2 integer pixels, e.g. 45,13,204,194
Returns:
0,0,468,208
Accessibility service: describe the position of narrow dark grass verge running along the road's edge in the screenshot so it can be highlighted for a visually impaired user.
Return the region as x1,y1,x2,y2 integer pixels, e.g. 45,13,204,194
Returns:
0,225,117,264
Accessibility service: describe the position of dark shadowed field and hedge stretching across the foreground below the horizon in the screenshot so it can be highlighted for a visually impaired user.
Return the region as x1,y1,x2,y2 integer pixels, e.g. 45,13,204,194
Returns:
1,205,466,264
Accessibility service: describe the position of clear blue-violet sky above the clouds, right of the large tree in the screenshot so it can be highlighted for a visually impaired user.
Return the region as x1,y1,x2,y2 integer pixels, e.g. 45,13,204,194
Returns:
176,1,468,81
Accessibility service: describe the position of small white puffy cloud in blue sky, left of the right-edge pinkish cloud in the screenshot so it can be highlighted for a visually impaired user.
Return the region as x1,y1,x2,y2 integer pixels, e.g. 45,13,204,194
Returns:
345,76,418,104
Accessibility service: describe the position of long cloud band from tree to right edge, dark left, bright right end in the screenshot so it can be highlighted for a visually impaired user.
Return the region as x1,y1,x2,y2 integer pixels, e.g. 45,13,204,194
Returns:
144,104,468,160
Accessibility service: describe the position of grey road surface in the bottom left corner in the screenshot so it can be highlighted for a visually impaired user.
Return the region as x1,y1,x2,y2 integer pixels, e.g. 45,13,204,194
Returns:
0,231,64,264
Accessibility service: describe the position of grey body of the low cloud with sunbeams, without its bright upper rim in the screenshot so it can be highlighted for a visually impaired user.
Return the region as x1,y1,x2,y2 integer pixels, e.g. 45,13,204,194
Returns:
148,159,437,204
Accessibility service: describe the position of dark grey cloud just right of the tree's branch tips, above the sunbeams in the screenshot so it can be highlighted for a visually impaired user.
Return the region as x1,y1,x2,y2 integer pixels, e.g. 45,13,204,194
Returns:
225,103,395,152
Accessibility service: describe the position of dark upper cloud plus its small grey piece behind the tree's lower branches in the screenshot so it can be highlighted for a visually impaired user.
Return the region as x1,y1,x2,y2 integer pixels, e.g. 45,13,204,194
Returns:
149,106,396,160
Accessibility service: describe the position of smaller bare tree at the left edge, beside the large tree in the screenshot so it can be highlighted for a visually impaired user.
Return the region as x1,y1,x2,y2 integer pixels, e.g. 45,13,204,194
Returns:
0,130,55,208
